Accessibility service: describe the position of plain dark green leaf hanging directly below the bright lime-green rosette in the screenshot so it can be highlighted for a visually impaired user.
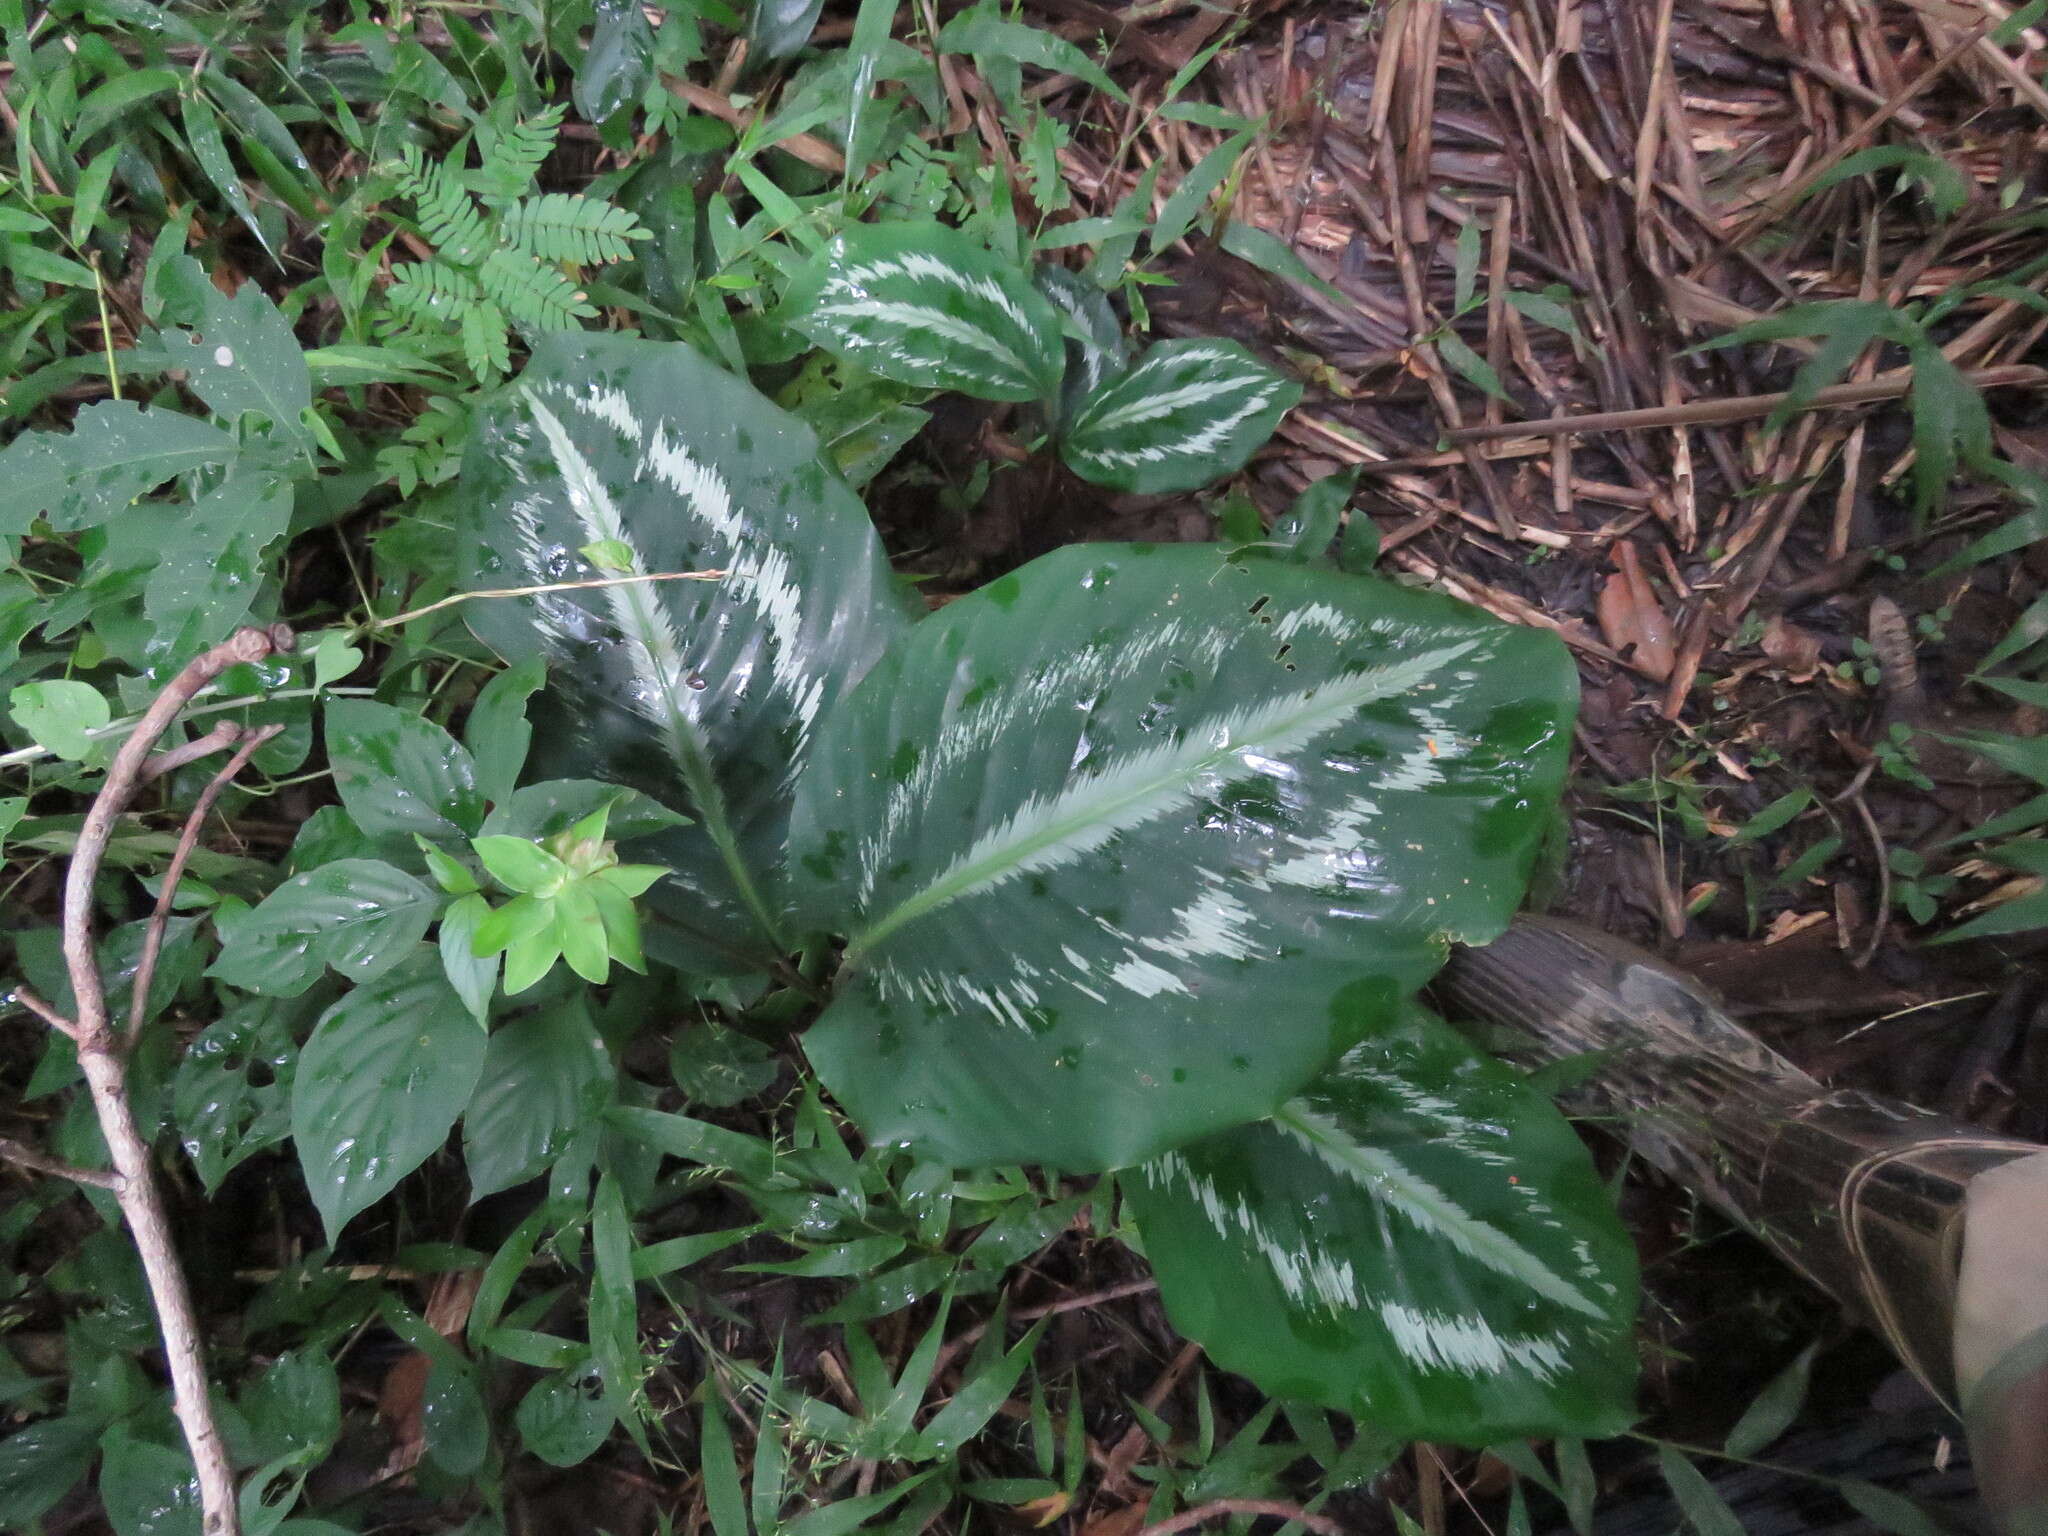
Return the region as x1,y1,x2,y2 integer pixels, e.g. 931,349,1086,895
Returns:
463,1001,612,1200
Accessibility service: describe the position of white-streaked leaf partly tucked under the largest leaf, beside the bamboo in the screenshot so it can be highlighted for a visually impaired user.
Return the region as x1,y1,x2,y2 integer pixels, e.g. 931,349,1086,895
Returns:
1122,1008,1636,1444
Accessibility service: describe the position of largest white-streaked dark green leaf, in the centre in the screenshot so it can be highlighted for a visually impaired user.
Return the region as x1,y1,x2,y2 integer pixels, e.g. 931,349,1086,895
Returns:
793,545,1577,1169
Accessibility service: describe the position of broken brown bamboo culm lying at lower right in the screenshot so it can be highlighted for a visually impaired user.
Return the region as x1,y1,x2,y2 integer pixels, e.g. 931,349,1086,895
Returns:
1436,918,2048,1532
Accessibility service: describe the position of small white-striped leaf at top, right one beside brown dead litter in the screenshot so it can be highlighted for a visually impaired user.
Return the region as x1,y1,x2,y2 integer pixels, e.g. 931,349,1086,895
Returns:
1061,340,1300,496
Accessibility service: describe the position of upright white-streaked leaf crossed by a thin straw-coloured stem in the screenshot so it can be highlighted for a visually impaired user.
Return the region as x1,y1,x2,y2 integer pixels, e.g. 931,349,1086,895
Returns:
459,334,907,965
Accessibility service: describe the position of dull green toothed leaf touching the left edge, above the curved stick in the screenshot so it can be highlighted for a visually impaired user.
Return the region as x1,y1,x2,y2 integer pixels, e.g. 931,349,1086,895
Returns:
0,399,238,535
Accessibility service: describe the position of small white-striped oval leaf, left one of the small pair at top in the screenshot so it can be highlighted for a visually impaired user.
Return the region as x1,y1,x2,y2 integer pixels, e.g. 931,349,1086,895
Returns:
784,223,1065,399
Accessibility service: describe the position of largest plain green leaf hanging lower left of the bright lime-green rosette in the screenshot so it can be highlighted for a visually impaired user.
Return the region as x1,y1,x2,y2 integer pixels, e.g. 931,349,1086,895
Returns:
291,948,483,1241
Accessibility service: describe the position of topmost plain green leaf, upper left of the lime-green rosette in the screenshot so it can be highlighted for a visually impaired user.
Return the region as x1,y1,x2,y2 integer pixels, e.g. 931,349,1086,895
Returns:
328,698,483,842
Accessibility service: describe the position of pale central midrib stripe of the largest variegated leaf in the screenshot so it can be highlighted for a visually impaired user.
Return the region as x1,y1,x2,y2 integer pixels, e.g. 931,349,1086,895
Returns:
844,641,1477,965
